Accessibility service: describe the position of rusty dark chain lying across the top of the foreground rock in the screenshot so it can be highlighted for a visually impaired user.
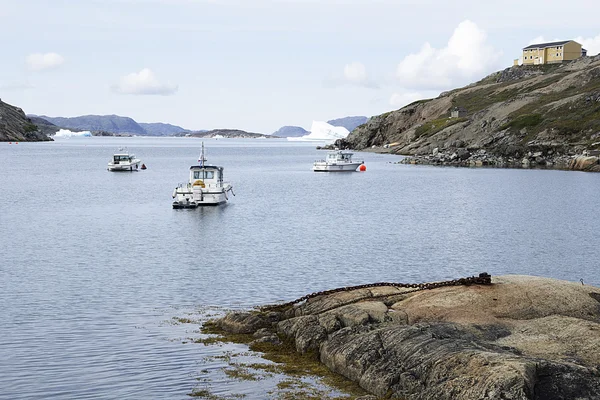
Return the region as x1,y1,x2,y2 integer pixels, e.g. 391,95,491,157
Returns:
261,272,492,311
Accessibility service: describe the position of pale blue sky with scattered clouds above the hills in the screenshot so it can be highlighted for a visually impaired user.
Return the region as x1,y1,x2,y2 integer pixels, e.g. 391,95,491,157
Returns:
0,0,600,133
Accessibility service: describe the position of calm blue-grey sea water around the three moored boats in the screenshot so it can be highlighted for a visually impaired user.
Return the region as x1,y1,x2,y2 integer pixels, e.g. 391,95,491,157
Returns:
0,138,600,399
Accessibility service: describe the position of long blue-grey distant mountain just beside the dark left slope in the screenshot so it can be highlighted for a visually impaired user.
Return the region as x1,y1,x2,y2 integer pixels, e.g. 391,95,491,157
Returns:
39,115,146,135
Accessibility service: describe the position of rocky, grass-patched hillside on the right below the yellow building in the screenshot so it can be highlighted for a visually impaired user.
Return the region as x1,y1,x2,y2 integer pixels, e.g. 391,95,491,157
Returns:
341,56,600,158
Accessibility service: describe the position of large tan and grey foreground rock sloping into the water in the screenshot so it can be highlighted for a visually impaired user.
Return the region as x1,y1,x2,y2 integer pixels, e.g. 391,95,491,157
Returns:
213,276,600,400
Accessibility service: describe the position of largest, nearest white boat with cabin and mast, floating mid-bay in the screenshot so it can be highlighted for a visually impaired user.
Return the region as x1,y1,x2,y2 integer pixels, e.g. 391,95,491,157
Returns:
173,143,235,208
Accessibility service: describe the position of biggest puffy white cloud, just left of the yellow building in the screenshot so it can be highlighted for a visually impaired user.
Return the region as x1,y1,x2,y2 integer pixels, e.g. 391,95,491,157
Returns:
396,20,502,89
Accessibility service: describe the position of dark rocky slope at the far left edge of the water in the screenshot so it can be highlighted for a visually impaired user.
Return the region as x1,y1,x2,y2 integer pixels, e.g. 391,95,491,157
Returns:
0,100,52,142
